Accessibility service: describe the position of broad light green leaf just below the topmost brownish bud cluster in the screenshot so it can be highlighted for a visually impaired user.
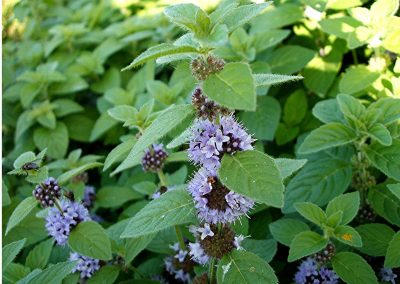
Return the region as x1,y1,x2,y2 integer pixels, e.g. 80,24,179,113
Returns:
203,62,256,111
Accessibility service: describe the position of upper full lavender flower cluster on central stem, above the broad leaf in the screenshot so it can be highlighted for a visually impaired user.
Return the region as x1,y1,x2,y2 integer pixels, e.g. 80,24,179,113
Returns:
188,115,254,172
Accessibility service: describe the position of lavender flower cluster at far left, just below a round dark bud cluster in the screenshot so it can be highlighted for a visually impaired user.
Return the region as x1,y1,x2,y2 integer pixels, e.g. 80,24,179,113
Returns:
46,199,91,245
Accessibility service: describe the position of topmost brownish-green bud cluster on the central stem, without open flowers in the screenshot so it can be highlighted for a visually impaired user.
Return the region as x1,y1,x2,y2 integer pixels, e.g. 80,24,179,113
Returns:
190,55,225,81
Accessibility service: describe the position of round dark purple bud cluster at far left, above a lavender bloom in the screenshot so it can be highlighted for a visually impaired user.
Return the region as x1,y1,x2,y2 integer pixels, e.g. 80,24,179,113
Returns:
32,177,61,208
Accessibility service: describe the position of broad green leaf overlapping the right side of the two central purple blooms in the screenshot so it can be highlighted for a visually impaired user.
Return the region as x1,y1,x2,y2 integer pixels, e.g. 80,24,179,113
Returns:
219,151,284,208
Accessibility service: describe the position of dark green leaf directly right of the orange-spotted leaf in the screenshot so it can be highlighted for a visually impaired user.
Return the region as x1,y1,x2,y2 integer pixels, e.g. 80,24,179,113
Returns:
356,223,394,256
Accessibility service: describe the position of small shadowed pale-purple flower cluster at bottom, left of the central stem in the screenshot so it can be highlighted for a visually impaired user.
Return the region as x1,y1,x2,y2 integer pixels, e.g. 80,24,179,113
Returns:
164,243,196,283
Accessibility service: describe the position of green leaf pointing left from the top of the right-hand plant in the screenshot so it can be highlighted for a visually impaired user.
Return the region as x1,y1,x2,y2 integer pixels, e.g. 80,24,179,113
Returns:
298,122,357,154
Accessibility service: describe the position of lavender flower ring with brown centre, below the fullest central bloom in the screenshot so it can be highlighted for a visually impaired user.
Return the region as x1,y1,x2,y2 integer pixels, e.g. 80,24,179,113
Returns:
188,168,254,224
